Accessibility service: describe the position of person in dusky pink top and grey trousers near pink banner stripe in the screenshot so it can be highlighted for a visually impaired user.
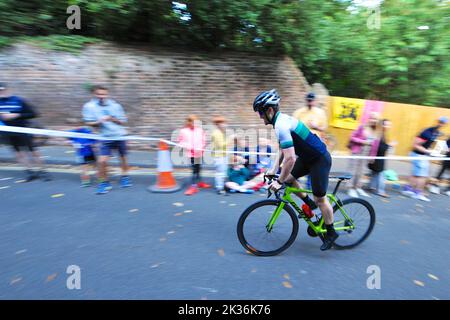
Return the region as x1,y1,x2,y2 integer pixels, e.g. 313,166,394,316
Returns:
348,112,378,198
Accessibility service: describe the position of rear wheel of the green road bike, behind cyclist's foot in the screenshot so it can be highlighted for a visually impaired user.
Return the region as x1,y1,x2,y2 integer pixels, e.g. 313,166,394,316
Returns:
333,198,375,249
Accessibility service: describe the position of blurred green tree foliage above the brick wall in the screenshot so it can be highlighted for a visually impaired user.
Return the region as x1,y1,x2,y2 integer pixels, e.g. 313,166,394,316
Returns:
0,0,450,107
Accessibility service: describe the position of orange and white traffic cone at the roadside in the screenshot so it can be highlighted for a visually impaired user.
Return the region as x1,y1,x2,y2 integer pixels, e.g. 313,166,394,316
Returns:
148,141,181,192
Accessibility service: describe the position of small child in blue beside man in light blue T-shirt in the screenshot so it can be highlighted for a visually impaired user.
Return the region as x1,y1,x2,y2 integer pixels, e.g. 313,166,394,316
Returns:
70,120,97,188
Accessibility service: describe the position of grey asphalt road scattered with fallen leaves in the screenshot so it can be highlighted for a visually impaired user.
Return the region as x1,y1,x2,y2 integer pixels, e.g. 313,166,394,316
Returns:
0,169,450,300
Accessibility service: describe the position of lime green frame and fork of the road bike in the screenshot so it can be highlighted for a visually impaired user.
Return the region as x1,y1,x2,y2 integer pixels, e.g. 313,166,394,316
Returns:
266,187,355,234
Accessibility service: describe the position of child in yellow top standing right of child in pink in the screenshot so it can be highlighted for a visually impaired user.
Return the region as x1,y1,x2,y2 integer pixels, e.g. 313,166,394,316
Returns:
211,117,228,194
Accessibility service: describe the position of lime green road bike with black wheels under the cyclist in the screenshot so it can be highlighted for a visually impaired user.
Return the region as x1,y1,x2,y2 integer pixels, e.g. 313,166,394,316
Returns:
237,173,375,256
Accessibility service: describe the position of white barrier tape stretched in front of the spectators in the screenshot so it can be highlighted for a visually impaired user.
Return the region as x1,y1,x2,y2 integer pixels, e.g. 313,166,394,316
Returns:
0,125,450,161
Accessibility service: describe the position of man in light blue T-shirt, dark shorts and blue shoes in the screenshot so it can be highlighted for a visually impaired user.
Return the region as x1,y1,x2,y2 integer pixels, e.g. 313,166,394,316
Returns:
83,86,132,194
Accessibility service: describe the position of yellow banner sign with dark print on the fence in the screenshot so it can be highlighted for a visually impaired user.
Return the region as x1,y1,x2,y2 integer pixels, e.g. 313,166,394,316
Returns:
331,97,365,130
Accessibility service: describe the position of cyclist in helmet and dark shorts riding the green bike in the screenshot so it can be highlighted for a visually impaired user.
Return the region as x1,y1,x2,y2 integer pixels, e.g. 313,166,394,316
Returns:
253,89,338,251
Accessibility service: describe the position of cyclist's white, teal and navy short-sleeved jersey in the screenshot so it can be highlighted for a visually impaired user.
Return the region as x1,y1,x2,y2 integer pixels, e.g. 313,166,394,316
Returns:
273,112,327,161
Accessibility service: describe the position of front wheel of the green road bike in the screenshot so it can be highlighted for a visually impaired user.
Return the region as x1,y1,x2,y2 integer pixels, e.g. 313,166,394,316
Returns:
237,200,298,256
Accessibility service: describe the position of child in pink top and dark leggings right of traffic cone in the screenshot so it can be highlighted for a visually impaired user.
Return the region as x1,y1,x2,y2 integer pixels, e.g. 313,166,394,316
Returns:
178,115,211,196
